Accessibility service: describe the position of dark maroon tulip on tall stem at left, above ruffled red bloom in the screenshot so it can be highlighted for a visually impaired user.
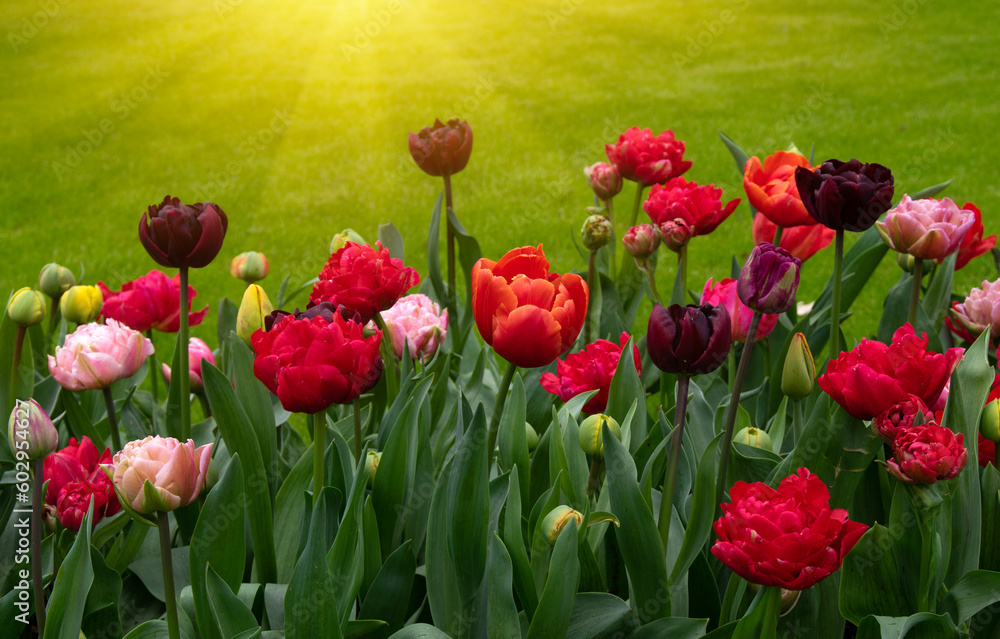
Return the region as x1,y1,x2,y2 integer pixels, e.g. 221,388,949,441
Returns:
139,195,229,268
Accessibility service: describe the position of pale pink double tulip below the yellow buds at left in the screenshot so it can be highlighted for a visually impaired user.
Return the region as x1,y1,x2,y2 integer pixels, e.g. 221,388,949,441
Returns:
49,319,153,391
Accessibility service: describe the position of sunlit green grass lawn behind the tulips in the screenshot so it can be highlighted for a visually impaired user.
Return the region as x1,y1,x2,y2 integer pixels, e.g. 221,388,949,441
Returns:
0,0,1000,350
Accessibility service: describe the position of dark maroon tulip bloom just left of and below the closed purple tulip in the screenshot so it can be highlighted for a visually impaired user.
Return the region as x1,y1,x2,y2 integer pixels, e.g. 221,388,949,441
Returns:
646,304,733,375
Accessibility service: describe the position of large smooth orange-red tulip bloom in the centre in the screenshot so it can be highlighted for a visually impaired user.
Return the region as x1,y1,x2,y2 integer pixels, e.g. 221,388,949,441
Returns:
472,245,589,368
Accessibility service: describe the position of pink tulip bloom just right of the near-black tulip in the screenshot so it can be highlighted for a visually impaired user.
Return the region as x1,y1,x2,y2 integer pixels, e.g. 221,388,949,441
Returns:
875,195,976,264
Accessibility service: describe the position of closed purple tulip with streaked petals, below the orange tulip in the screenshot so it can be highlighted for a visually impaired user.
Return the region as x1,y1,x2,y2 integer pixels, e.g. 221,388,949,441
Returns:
736,242,802,315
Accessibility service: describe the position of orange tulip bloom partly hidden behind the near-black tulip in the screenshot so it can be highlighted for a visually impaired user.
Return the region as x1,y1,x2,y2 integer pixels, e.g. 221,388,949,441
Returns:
743,151,816,228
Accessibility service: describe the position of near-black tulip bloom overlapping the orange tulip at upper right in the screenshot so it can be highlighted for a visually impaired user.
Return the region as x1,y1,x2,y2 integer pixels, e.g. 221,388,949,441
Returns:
795,160,893,232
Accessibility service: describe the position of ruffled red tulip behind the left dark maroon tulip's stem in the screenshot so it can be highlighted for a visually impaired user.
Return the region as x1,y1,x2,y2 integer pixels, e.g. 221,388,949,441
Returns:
97,270,208,333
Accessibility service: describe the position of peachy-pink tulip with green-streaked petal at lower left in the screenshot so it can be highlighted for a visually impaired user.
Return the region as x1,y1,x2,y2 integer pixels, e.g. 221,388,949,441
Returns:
112,435,212,515
